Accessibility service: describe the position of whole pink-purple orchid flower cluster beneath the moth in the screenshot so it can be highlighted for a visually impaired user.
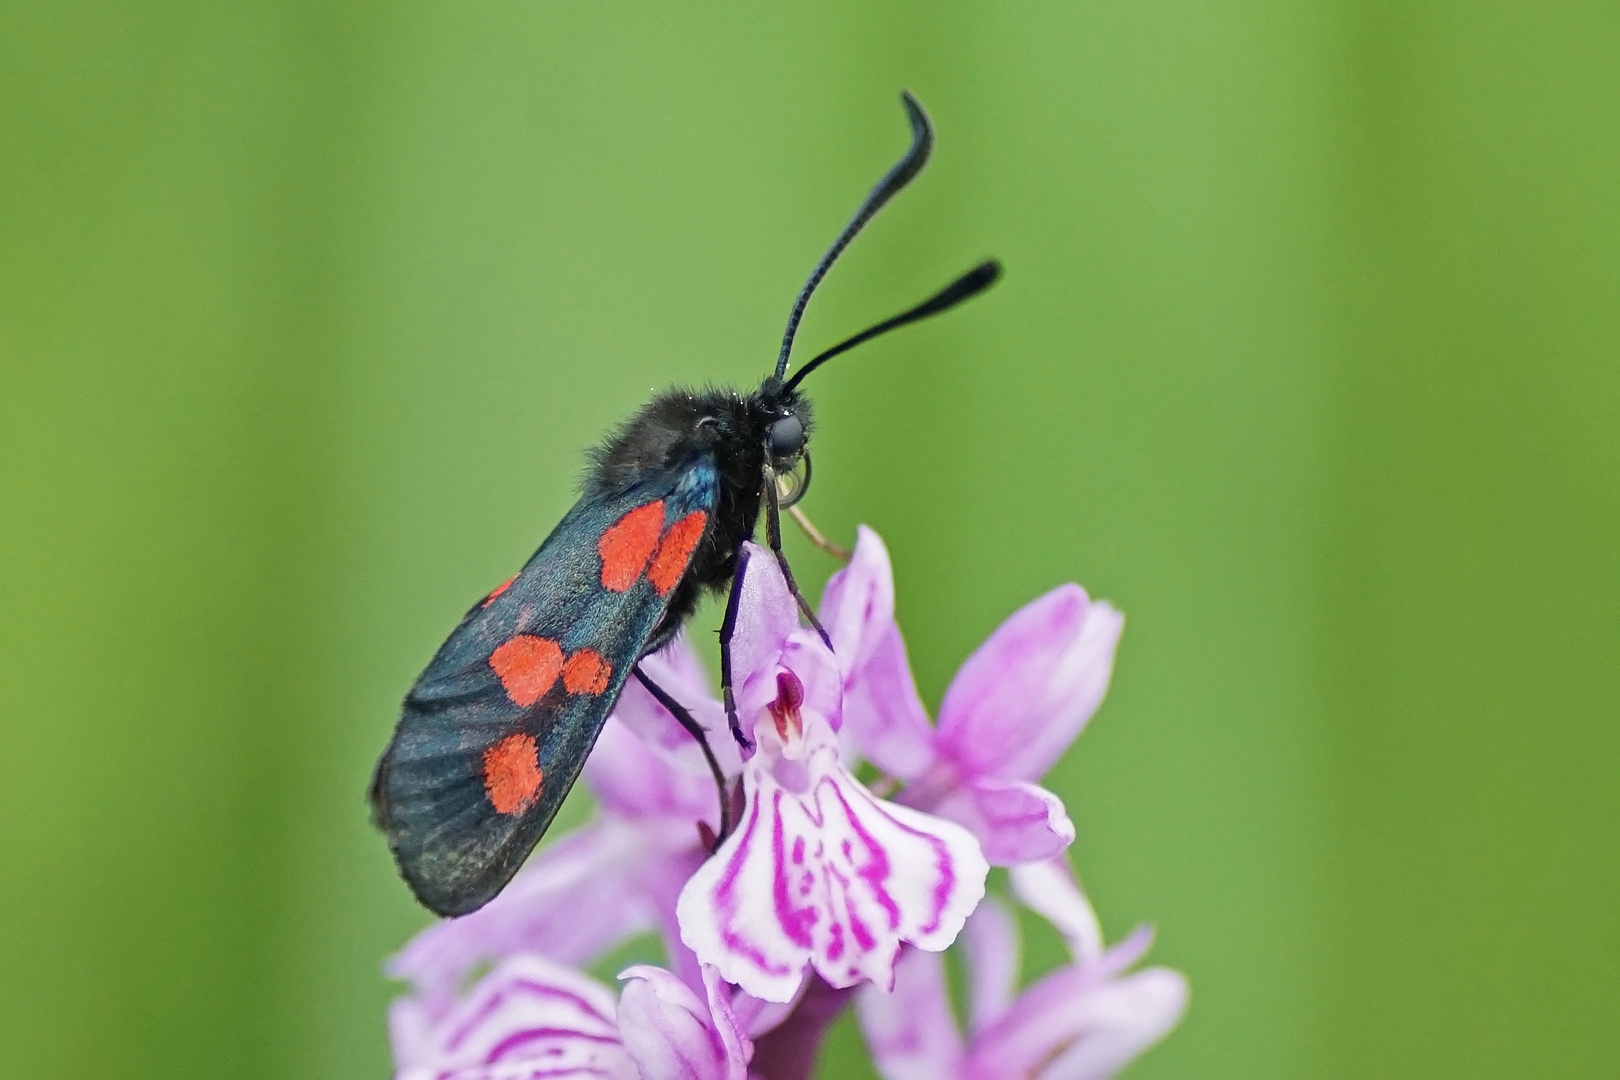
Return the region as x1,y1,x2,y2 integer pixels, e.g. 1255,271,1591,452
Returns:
389,529,1186,1080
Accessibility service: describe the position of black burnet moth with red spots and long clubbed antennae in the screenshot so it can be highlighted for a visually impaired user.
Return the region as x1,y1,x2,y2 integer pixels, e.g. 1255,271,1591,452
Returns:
371,94,1000,915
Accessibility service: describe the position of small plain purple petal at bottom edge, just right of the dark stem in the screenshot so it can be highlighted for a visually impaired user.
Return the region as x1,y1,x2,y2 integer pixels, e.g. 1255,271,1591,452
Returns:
855,949,962,1080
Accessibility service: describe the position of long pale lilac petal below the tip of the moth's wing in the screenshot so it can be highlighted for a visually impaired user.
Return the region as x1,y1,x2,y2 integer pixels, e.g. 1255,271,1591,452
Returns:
387,819,660,1017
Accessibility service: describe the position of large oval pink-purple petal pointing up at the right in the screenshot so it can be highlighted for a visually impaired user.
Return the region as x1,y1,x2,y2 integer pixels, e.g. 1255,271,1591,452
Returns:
940,585,1123,780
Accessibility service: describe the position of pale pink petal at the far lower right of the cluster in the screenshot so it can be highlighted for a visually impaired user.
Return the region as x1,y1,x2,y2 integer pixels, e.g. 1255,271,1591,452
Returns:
964,965,1187,1080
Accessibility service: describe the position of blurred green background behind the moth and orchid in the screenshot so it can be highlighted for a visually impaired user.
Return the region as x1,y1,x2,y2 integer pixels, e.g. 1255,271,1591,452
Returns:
0,0,1620,1080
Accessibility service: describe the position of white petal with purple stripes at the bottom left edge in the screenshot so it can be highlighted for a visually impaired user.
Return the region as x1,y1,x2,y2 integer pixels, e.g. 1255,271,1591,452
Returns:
400,954,635,1080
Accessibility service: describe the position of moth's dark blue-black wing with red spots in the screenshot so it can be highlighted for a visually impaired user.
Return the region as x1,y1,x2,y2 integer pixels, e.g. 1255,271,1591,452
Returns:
371,457,718,915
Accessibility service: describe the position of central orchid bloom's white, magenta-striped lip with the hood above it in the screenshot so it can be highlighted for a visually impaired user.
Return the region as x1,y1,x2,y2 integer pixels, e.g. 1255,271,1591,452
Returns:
676,540,990,1001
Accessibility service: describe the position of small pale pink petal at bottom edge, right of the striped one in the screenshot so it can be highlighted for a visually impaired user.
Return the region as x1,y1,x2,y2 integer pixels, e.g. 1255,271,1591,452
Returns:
619,965,740,1080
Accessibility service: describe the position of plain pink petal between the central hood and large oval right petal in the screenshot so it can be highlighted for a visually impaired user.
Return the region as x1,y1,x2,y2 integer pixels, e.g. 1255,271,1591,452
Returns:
844,623,935,780
